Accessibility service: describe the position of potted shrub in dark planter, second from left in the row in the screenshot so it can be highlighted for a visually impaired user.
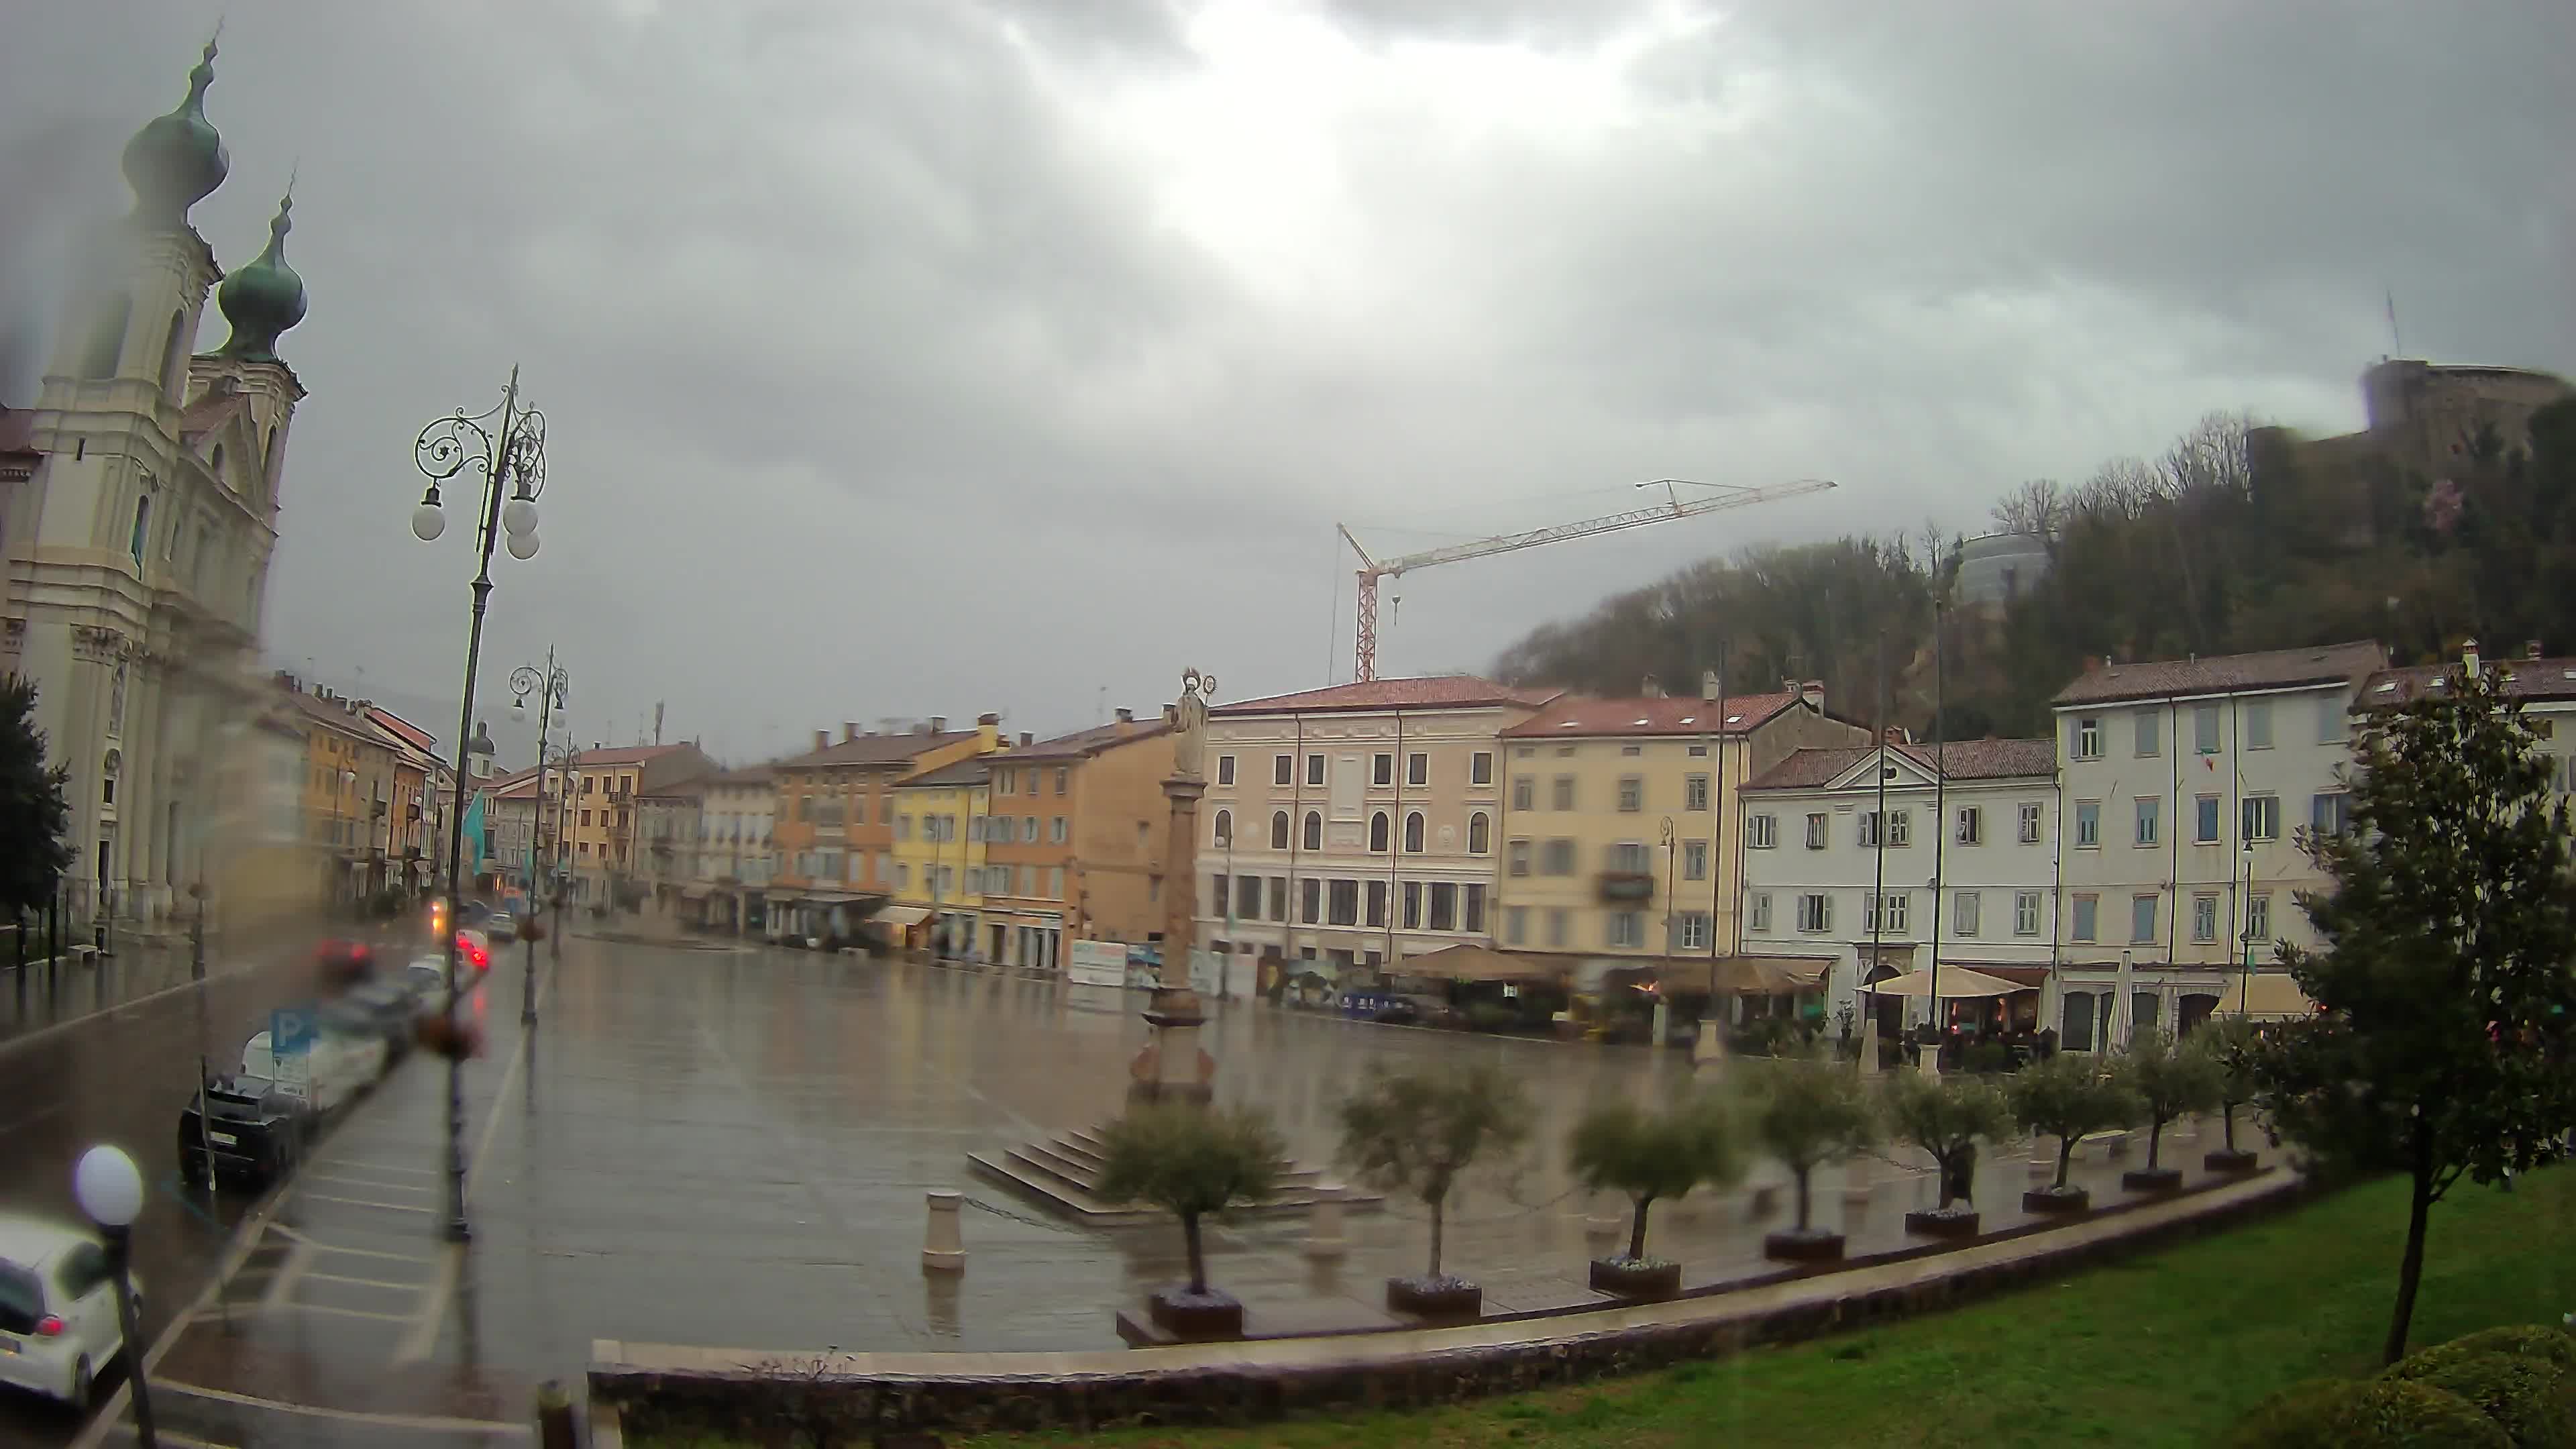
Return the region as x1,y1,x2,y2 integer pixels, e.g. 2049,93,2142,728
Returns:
1340,1065,1530,1318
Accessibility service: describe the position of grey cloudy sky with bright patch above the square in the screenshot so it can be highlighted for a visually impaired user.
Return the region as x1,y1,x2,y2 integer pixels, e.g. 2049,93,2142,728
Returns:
0,0,2576,758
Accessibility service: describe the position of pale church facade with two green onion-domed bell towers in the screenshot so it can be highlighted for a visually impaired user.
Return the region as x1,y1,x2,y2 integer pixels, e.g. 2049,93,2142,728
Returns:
0,44,304,920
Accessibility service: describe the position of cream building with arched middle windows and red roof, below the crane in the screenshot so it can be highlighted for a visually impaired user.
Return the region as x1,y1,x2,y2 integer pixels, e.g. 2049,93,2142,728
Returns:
1198,676,1556,982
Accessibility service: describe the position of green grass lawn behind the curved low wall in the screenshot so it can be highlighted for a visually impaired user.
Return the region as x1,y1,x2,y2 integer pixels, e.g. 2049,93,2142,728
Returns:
634,1168,2576,1449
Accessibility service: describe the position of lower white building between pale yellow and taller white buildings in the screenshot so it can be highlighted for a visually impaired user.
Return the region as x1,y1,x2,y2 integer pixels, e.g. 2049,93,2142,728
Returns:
1741,740,2058,1031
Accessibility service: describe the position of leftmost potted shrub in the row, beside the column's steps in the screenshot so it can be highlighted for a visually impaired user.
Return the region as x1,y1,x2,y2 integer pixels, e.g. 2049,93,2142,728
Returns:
1100,1104,1285,1338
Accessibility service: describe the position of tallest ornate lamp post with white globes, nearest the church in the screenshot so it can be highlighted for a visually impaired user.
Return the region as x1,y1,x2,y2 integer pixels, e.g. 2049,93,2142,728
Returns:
412,366,546,1243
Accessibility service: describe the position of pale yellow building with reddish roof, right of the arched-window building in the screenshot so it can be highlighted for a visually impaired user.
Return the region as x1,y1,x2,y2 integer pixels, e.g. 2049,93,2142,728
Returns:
1494,681,1870,990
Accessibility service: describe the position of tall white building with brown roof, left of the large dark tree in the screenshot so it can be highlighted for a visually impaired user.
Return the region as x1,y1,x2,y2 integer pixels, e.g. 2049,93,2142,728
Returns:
2053,642,2388,1046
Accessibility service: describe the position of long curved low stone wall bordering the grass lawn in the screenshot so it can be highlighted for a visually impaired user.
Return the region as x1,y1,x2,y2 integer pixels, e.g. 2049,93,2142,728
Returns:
590,1168,2308,1439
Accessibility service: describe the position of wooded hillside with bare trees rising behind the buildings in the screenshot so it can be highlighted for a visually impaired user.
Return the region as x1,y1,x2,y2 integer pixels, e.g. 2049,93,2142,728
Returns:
1494,402,2576,740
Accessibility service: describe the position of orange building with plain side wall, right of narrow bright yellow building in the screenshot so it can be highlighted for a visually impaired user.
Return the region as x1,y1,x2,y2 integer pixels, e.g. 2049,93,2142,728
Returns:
979,709,1172,972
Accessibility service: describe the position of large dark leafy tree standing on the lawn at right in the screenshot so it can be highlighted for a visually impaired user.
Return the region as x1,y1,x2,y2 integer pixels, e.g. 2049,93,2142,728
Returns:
2249,655,2576,1361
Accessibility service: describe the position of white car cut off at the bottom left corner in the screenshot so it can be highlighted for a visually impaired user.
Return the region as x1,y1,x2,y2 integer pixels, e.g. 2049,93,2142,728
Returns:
0,1217,144,1408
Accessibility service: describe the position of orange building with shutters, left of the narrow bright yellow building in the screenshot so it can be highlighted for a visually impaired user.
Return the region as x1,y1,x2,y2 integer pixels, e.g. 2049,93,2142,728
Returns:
767,714,1002,941
